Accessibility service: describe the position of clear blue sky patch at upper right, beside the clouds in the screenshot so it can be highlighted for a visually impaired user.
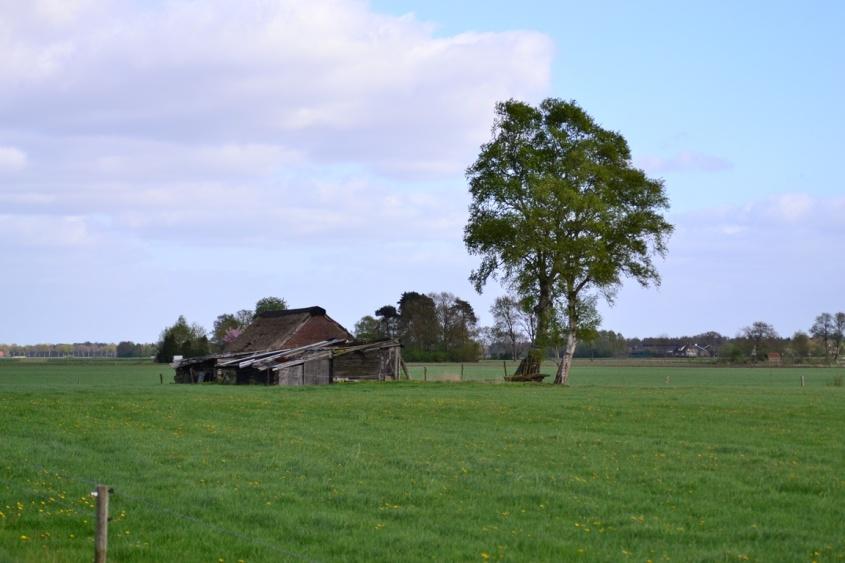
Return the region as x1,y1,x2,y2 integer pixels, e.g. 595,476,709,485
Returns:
373,0,845,211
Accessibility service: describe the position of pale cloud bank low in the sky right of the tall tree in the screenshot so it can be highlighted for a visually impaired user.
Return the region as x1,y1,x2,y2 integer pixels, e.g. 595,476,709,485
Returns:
604,193,845,336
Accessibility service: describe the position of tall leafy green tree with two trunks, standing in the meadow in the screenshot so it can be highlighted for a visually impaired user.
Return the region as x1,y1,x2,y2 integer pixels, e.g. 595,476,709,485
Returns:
464,99,672,383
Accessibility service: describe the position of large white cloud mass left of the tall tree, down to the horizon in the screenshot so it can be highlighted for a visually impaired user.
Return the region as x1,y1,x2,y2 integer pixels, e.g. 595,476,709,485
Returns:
0,0,553,340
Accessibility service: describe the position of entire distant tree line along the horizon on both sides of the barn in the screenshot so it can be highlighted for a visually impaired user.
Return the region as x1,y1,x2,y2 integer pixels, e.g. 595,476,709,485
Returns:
14,298,845,364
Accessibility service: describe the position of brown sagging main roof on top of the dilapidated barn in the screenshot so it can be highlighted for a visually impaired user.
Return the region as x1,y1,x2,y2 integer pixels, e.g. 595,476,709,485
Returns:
226,307,353,354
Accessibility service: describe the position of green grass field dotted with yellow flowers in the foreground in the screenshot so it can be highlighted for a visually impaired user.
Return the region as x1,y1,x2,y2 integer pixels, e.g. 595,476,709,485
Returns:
0,362,845,562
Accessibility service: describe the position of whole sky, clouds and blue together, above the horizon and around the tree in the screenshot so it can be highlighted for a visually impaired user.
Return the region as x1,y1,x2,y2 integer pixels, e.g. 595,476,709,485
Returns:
0,0,845,344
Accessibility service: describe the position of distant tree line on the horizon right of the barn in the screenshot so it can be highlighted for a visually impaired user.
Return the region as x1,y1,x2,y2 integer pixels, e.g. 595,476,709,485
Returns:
354,291,845,364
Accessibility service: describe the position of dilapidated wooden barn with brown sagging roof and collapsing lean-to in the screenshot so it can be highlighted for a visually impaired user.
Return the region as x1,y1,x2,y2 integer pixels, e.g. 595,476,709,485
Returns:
173,307,404,385
